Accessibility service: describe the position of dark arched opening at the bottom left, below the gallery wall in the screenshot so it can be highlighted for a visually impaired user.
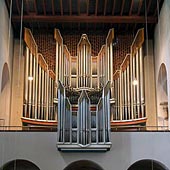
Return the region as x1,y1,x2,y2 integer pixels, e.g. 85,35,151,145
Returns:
0,159,40,170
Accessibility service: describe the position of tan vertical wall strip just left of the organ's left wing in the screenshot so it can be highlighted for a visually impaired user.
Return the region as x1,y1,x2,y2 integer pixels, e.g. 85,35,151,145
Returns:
10,39,24,126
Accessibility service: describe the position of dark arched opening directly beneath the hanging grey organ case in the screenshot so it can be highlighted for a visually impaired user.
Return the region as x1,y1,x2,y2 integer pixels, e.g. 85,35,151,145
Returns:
64,160,103,170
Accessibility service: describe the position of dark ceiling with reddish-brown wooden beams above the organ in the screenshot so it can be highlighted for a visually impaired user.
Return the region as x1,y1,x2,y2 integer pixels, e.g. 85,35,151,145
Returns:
5,0,163,34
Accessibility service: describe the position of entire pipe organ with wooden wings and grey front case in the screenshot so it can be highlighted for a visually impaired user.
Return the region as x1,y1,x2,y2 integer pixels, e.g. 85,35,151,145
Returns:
21,28,147,151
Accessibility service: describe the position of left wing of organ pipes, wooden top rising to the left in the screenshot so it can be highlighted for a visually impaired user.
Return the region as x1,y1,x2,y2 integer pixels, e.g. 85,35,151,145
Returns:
22,28,57,125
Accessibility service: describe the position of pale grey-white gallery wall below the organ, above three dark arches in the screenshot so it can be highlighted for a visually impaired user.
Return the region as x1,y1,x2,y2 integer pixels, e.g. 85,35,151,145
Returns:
0,132,170,170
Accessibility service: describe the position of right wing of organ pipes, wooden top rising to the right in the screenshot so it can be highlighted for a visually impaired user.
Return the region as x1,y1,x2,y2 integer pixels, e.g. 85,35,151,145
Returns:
111,29,146,122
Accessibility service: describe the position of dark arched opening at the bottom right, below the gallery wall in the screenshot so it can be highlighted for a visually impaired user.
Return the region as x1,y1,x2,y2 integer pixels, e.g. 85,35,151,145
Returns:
128,159,169,170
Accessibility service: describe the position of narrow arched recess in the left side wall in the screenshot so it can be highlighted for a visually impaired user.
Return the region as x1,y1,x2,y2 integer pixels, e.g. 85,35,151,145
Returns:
1,63,10,92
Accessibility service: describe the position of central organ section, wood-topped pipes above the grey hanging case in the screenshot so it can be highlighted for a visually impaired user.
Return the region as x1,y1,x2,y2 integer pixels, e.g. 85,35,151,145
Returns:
55,29,114,151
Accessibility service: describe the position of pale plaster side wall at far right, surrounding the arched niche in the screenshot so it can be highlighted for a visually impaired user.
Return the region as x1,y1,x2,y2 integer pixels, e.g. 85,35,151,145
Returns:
154,0,170,127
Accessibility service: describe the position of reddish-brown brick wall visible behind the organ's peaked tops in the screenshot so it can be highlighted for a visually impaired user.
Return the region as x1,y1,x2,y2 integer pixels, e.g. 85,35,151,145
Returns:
34,31,133,71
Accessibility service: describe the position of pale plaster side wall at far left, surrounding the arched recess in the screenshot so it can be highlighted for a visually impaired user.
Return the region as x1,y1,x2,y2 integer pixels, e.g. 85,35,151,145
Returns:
0,0,13,125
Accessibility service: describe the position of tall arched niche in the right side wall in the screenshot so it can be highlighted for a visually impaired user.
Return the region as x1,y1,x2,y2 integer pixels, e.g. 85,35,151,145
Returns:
157,63,168,126
